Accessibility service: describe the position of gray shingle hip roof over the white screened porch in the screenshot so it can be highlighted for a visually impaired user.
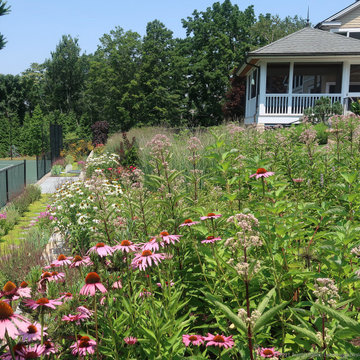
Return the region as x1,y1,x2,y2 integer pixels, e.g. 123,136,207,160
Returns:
248,27,360,57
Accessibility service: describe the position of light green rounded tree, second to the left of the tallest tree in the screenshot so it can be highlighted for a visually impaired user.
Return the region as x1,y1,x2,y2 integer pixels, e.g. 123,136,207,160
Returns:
85,27,141,131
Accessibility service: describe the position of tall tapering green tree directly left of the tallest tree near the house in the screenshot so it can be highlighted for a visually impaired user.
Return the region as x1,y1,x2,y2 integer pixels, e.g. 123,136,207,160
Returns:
120,20,181,130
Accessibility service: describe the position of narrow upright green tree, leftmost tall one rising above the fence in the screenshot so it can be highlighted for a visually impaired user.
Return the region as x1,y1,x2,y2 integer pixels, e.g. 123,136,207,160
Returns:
45,35,87,114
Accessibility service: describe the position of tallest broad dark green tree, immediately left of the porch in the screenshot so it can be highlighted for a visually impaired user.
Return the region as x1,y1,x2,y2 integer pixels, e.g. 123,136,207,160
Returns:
182,0,255,125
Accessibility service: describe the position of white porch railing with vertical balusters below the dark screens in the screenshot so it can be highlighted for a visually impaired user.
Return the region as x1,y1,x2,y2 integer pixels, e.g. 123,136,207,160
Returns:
265,94,342,115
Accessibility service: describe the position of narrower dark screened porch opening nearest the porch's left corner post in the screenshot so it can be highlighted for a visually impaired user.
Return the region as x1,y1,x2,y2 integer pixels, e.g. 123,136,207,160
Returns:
266,63,290,94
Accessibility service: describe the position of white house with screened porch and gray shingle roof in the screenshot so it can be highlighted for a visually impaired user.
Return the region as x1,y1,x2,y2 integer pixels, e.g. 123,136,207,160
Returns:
238,1,360,125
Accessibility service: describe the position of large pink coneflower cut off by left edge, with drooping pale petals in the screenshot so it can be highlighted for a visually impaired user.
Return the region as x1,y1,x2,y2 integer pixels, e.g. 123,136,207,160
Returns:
0,300,30,340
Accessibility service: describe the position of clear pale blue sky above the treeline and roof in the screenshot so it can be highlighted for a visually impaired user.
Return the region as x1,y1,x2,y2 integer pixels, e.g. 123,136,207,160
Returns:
0,0,354,75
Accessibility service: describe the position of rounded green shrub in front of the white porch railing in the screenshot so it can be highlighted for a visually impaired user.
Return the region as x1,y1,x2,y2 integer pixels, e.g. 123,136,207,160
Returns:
304,97,343,124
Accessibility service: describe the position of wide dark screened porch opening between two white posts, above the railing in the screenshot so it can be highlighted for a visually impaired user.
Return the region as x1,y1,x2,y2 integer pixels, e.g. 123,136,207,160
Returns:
293,63,342,94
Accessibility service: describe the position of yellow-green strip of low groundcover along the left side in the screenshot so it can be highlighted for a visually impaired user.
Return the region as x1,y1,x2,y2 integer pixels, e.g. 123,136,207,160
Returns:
0,194,50,253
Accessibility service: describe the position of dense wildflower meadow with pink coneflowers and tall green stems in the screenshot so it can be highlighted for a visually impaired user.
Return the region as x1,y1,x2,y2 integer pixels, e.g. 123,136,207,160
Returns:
0,115,360,360
